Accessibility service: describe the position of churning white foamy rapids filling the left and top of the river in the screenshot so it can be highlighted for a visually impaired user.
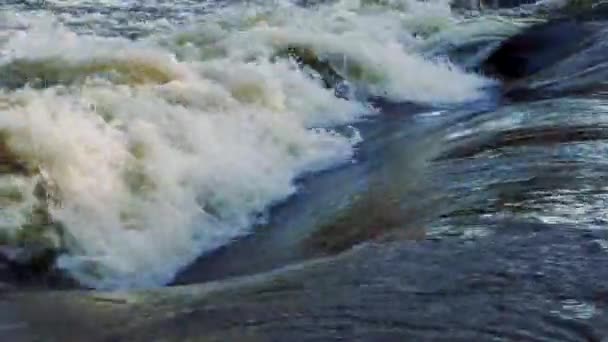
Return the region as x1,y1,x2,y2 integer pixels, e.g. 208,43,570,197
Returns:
0,0,496,289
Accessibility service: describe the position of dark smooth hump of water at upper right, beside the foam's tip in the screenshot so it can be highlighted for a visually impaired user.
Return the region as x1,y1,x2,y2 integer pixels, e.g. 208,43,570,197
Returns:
481,4,608,101
